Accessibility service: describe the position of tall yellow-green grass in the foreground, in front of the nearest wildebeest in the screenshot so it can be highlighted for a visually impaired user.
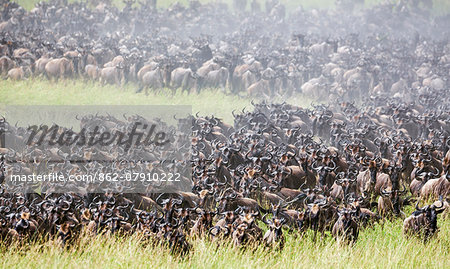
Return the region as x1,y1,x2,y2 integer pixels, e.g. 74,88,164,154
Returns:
0,216,450,268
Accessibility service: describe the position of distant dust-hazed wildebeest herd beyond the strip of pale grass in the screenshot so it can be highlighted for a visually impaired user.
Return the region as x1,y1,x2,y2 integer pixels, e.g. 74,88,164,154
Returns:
0,0,450,97
